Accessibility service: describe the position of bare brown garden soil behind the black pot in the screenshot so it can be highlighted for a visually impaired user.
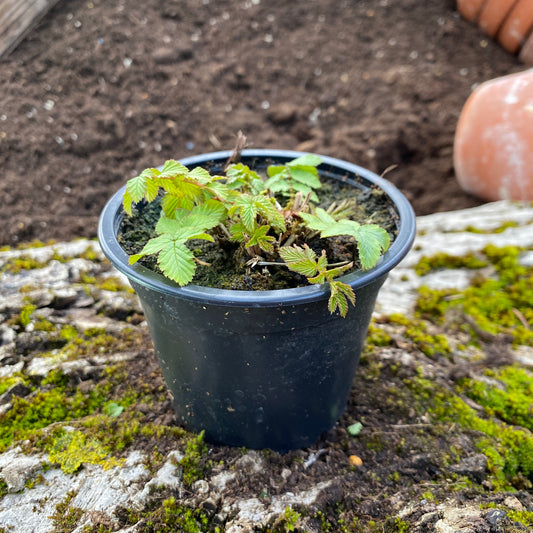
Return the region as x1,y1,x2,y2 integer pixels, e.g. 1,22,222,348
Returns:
0,0,524,245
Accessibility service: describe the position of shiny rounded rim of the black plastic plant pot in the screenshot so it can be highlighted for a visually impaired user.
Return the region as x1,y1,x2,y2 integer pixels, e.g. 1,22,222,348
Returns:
98,149,416,307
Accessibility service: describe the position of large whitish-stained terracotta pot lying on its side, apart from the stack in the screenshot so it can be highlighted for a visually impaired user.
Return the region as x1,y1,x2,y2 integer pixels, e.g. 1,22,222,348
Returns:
454,69,533,201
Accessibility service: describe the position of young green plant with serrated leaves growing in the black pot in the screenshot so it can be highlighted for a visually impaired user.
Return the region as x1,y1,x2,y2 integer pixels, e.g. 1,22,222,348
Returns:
123,155,390,316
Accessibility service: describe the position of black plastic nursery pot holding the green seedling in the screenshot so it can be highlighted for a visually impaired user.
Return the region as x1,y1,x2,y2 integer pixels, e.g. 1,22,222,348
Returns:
98,150,415,451
